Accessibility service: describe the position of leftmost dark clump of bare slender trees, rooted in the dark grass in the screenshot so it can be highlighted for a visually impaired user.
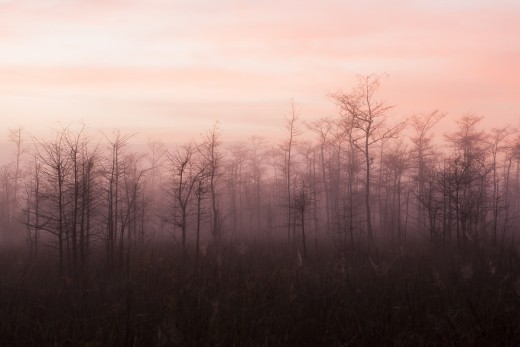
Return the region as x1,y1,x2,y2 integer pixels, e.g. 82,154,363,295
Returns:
28,127,100,279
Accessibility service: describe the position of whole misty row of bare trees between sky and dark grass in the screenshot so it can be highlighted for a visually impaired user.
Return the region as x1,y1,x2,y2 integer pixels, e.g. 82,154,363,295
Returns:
0,75,520,276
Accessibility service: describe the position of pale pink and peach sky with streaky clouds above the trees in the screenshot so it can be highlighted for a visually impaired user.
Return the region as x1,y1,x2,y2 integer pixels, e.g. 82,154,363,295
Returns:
0,0,520,142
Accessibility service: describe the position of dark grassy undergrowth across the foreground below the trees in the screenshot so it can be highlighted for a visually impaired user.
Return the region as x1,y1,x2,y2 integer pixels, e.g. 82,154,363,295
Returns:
0,239,520,346
